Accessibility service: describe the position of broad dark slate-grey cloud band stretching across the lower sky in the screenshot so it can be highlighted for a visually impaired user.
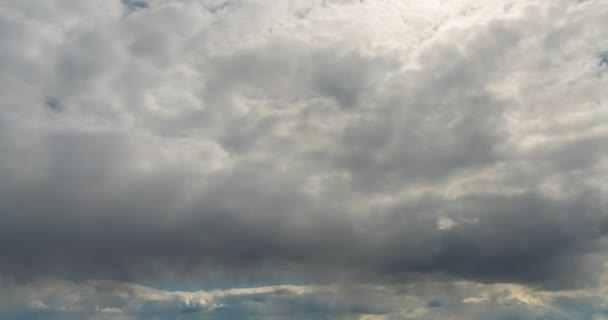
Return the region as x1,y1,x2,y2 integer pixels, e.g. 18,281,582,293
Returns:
0,149,606,286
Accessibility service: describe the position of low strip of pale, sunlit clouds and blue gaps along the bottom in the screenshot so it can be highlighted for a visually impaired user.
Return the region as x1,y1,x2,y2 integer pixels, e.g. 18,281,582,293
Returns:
0,280,608,320
